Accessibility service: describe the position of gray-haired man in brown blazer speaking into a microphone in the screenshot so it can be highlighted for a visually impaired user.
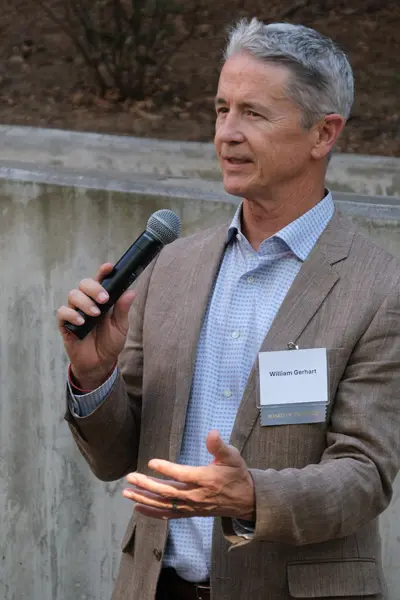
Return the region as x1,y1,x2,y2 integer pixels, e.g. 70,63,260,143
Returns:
58,19,400,600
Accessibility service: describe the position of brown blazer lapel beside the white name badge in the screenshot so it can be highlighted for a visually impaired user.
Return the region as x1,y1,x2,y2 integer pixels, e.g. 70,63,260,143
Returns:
230,213,354,452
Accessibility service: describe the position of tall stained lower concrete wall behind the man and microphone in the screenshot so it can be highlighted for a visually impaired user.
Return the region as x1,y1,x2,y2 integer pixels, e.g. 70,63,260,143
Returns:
0,130,400,600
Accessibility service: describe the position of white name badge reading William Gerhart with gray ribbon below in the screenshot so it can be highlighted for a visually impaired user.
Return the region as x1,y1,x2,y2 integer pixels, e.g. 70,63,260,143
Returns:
258,348,328,425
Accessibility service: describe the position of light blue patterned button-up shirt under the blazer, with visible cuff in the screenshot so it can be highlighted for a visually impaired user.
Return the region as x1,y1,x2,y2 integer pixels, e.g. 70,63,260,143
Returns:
71,193,334,581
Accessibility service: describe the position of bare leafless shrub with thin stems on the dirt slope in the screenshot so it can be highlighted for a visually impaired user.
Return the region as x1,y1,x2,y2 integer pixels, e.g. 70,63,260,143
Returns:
36,0,202,100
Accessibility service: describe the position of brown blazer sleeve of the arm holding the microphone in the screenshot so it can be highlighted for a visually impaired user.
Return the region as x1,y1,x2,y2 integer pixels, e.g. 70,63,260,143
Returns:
65,261,155,481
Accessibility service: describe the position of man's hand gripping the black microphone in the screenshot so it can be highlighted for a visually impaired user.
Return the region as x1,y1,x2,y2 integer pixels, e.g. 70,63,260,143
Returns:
57,263,135,390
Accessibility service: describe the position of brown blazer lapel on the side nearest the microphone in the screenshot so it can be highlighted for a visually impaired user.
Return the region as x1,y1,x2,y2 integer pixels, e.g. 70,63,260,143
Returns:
169,224,228,462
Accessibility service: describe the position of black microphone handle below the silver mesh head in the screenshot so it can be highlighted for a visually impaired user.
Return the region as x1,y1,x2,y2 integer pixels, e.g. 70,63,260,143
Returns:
64,230,164,340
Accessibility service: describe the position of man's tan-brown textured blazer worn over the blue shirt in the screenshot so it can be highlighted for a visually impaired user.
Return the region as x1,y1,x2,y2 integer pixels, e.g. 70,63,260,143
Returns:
67,209,400,600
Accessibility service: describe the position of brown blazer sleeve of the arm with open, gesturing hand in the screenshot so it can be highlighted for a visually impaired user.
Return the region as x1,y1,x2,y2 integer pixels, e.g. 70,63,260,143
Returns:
222,292,400,545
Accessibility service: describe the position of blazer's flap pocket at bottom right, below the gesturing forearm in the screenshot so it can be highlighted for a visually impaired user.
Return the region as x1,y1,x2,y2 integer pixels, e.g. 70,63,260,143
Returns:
287,558,382,600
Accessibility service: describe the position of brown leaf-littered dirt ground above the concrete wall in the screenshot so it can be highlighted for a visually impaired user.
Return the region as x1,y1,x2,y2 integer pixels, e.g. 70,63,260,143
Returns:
0,0,400,156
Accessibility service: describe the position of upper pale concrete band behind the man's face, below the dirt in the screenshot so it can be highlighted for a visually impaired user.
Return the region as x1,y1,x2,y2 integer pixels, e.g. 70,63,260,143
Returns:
0,126,400,196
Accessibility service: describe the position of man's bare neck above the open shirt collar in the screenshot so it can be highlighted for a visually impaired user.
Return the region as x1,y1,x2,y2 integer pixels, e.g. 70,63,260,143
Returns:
242,177,325,251
